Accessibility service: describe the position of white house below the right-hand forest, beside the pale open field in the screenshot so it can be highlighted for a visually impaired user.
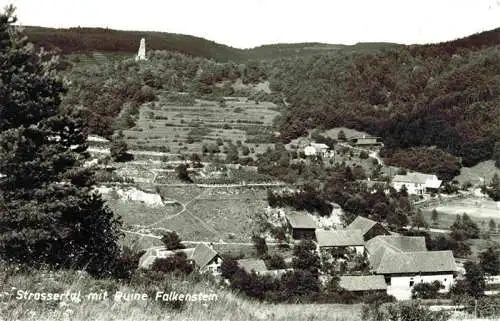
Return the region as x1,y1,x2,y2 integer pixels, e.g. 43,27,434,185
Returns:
392,172,443,195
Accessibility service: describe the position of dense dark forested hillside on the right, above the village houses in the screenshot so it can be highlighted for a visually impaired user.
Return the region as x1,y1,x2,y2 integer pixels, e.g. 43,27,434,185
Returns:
268,29,500,178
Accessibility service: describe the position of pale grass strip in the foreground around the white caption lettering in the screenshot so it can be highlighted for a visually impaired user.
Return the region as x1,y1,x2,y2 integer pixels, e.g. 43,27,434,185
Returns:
0,266,361,321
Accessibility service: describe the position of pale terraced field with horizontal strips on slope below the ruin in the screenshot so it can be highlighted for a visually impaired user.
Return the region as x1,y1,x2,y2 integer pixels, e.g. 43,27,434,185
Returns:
124,95,280,159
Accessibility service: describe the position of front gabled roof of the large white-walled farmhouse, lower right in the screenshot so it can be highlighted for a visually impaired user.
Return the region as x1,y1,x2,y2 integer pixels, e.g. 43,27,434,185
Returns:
375,250,457,274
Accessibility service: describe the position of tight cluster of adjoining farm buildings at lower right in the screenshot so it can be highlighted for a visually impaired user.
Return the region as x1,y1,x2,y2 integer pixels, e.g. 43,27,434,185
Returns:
289,214,457,300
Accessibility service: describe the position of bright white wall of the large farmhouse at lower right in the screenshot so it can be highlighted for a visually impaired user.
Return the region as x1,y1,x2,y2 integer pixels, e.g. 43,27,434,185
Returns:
387,274,454,300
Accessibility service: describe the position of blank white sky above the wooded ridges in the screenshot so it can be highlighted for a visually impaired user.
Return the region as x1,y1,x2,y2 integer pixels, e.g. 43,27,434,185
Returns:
0,0,500,48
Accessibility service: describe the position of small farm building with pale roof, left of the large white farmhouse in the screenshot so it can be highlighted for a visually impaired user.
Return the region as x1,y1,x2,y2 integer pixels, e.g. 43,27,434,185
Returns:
316,229,365,255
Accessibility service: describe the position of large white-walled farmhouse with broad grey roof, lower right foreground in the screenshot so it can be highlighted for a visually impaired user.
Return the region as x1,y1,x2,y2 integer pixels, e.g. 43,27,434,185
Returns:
374,251,457,300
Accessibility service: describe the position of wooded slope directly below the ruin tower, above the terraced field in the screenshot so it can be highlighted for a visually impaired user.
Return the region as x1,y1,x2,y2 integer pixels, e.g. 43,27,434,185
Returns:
63,51,272,136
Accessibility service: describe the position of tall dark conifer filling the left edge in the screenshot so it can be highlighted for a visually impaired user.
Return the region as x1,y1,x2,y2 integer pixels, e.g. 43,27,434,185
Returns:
0,6,120,275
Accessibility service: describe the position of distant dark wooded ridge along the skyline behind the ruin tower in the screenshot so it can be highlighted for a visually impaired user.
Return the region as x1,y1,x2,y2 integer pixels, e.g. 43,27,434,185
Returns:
24,27,399,62
